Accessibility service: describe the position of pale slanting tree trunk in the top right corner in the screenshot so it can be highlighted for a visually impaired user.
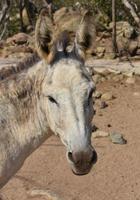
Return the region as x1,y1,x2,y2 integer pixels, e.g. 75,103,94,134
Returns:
122,0,140,28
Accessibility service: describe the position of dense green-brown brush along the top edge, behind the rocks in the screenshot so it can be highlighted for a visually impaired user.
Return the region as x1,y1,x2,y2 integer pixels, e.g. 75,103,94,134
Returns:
0,0,140,39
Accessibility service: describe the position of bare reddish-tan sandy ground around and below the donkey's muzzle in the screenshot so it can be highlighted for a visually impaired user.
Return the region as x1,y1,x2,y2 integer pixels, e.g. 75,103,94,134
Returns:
1,78,140,200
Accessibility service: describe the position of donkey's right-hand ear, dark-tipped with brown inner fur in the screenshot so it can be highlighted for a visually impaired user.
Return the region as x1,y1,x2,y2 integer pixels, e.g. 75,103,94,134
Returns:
74,11,96,61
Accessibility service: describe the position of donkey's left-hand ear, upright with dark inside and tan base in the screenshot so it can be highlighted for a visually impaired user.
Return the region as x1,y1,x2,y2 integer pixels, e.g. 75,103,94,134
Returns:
35,8,55,63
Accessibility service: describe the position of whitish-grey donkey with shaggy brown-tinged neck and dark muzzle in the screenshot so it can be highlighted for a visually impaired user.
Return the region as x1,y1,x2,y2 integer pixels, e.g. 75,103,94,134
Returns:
0,9,97,187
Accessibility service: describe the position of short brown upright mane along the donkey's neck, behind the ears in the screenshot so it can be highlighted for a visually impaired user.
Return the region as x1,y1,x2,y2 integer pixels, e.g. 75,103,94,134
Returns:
0,52,41,82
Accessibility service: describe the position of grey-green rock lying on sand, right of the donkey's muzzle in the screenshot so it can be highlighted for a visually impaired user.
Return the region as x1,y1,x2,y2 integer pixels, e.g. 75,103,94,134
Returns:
109,132,127,144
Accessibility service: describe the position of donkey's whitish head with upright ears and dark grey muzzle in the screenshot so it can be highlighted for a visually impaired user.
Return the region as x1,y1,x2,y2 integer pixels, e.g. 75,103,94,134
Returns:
36,10,97,175
